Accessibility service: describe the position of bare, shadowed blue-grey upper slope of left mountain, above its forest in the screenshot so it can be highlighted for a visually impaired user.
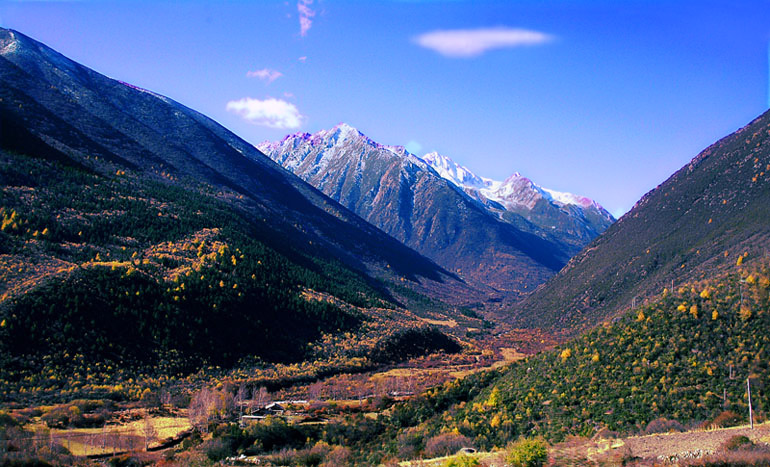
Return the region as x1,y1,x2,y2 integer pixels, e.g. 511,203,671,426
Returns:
0,30,460,288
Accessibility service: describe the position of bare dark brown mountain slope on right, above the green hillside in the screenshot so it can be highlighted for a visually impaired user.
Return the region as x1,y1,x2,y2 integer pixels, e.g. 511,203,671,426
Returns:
513,109,770,333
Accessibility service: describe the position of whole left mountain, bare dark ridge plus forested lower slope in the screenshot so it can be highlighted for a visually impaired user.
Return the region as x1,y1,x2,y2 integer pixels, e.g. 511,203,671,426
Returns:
0,29,480,381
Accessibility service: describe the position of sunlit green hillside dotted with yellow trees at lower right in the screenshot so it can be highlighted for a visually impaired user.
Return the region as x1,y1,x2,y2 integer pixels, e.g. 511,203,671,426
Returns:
402,255,770,448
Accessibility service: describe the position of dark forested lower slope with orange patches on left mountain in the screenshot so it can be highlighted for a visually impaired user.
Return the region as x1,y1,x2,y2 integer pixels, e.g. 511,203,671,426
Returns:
0,148,378,372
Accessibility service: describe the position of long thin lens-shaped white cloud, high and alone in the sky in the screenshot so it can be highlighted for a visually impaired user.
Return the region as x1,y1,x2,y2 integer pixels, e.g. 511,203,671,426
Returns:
414,27,553,58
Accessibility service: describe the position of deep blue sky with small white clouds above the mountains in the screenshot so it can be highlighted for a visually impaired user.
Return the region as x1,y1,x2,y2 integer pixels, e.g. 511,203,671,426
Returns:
0,0,770,216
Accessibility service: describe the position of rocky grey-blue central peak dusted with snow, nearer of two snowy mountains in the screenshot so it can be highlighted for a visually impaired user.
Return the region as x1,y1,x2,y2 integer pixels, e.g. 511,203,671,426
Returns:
258,124,569,297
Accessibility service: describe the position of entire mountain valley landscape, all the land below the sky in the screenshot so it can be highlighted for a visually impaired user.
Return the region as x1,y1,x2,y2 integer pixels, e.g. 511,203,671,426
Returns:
0,17,770,467
